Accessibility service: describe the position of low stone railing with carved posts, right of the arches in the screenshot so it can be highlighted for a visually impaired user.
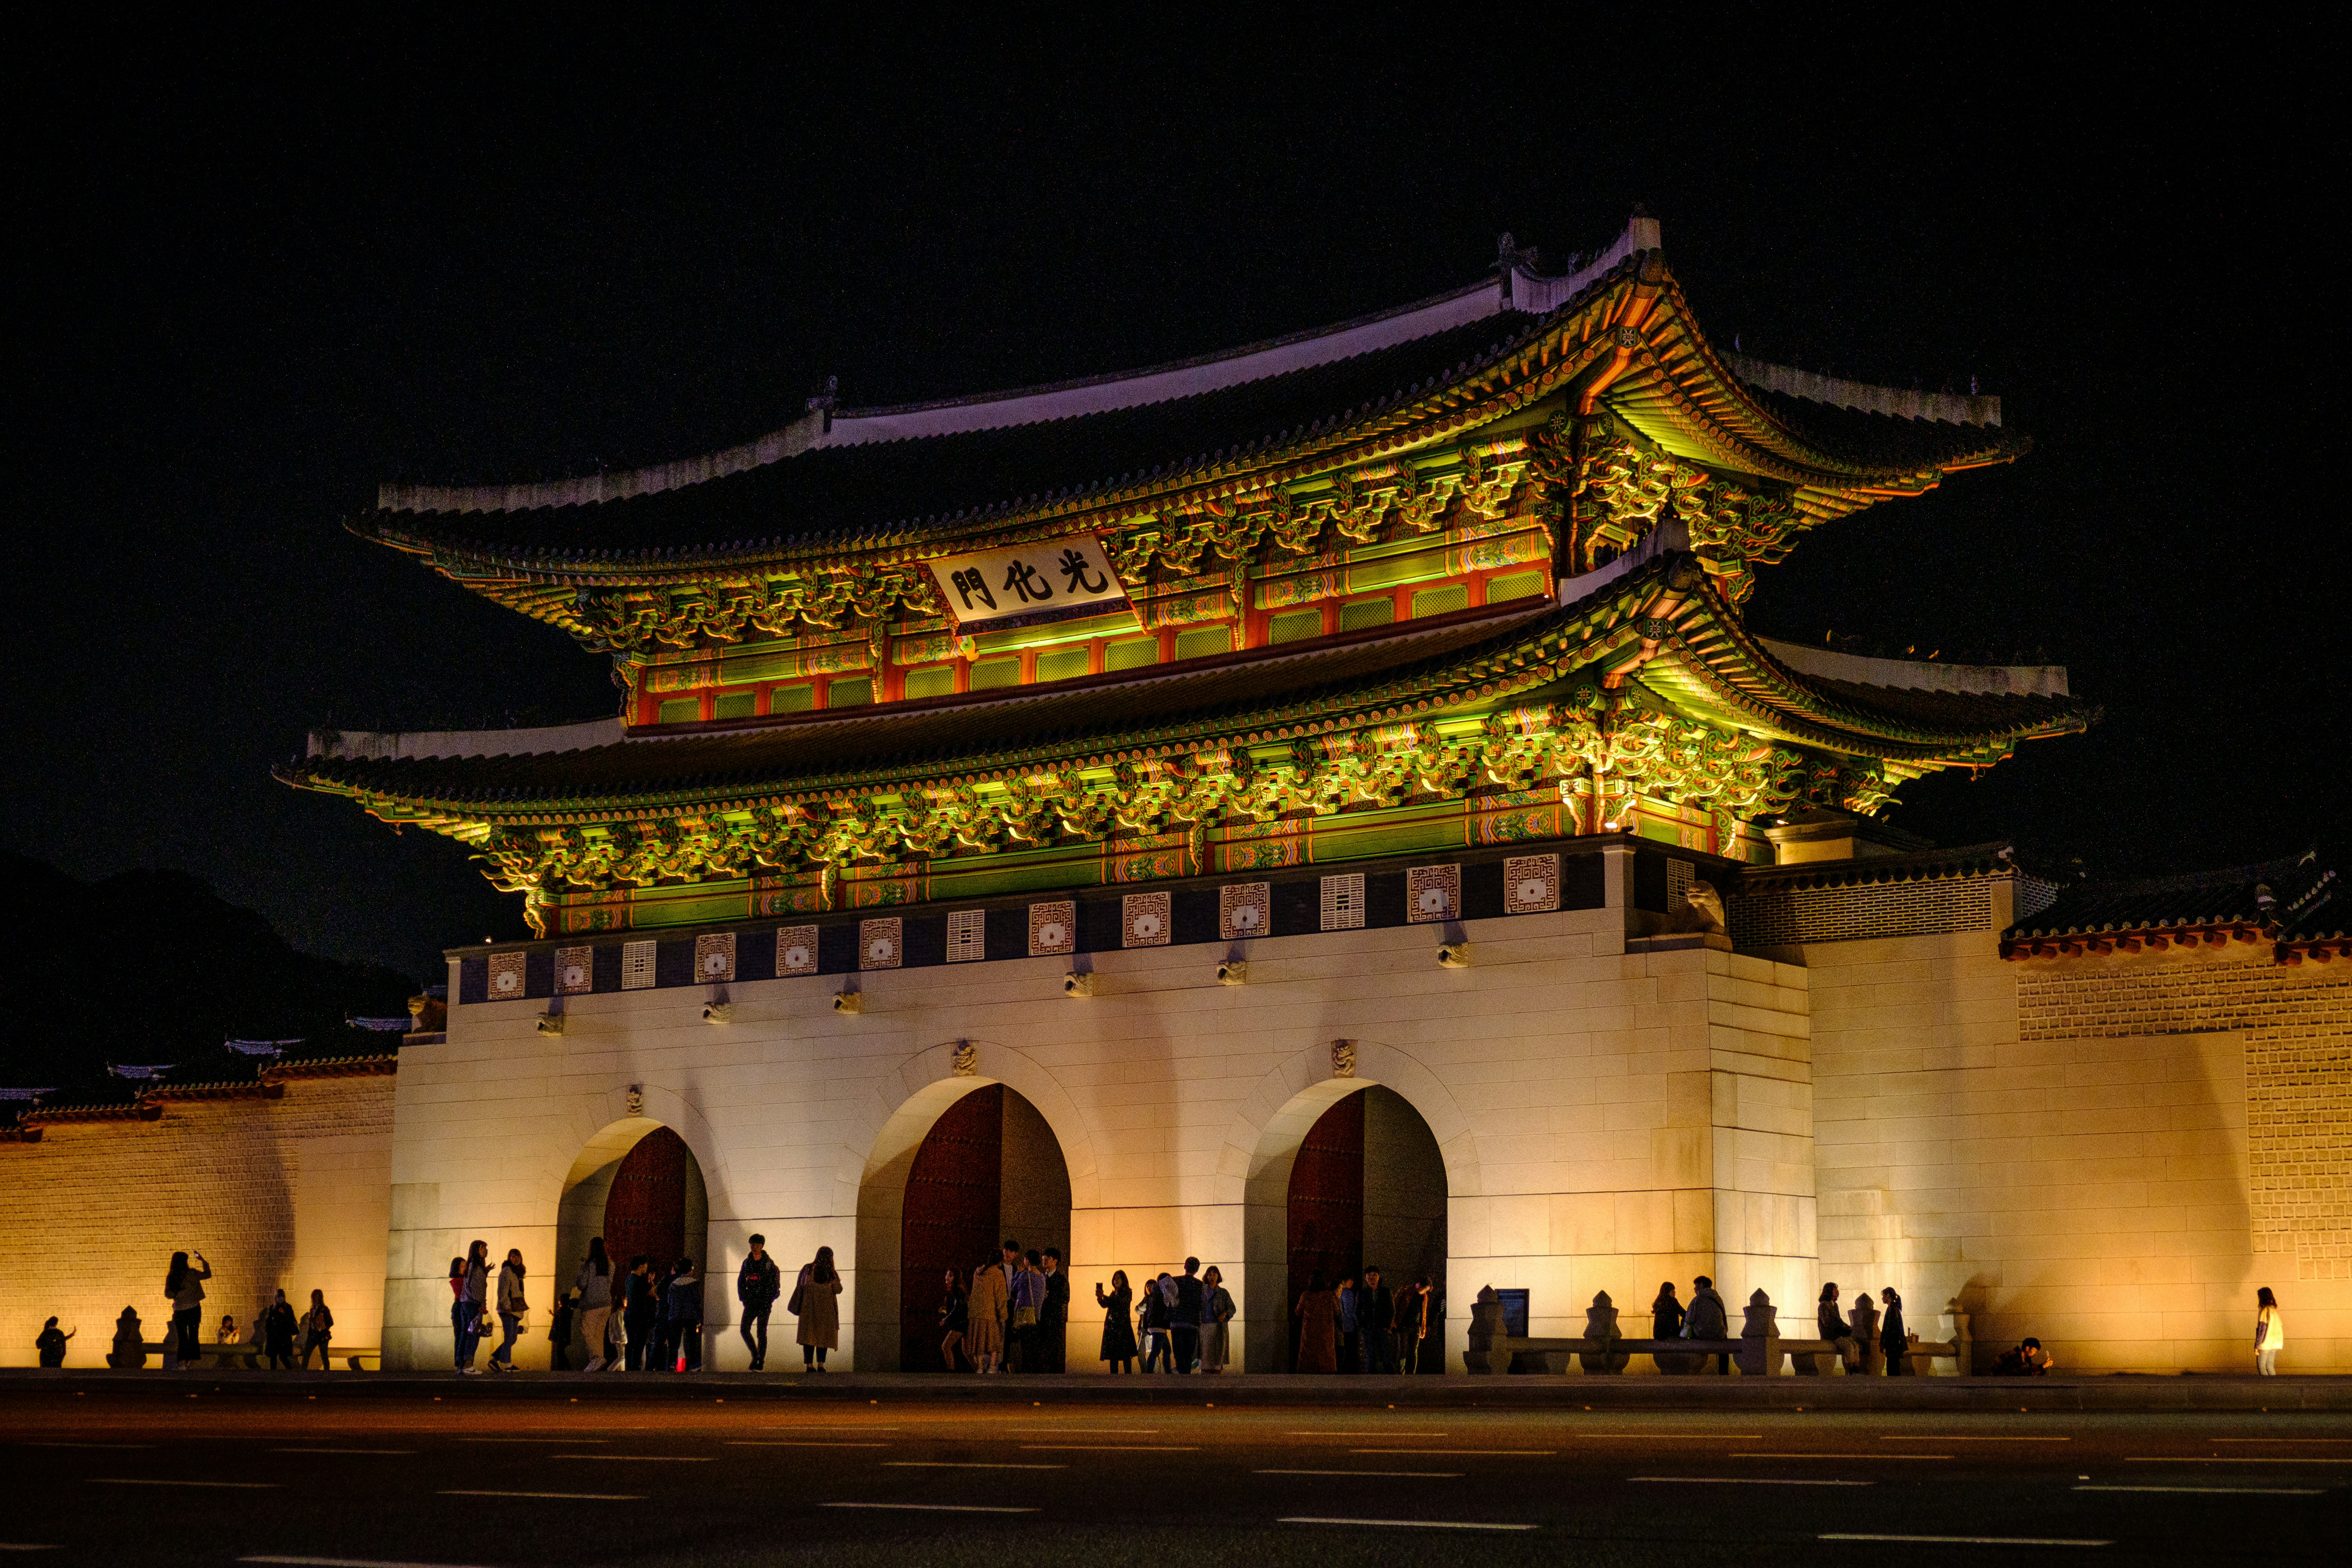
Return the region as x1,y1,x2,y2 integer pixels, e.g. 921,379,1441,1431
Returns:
1463,1286,1976,1378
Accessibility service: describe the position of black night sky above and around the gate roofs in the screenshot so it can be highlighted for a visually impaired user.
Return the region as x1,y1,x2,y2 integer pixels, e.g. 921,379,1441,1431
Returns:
14,18,2347,975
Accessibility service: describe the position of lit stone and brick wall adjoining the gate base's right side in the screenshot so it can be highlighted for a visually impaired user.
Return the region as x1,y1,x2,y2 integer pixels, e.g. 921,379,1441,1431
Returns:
1783,926,2352,1370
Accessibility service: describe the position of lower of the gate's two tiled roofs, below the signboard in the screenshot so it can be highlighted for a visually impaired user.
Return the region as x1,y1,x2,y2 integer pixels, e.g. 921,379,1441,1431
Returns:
280,548,2096,818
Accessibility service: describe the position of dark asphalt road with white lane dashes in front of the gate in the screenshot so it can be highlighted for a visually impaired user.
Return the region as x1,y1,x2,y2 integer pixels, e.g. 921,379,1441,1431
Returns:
0,1387,2352,1568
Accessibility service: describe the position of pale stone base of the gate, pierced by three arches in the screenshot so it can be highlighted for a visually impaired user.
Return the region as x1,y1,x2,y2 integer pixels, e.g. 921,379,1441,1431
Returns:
400,851,1813,1370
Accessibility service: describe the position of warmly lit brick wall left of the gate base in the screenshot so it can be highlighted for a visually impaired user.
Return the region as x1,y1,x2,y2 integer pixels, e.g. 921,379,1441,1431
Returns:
0,1076,393,1366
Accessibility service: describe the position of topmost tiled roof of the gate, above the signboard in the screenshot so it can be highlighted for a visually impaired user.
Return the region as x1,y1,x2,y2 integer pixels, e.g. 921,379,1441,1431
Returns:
355,216,2025,581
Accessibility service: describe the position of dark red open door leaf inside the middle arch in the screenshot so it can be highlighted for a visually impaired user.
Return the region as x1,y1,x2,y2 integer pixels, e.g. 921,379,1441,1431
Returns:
899,1084,1004,1373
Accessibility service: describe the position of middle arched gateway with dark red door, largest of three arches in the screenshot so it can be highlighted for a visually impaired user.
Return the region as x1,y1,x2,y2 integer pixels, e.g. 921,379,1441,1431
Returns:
859,1079,1070,1370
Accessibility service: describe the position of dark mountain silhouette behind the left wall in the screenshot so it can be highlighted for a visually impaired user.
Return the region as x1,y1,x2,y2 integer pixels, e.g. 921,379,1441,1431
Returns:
0,853,416,1089
